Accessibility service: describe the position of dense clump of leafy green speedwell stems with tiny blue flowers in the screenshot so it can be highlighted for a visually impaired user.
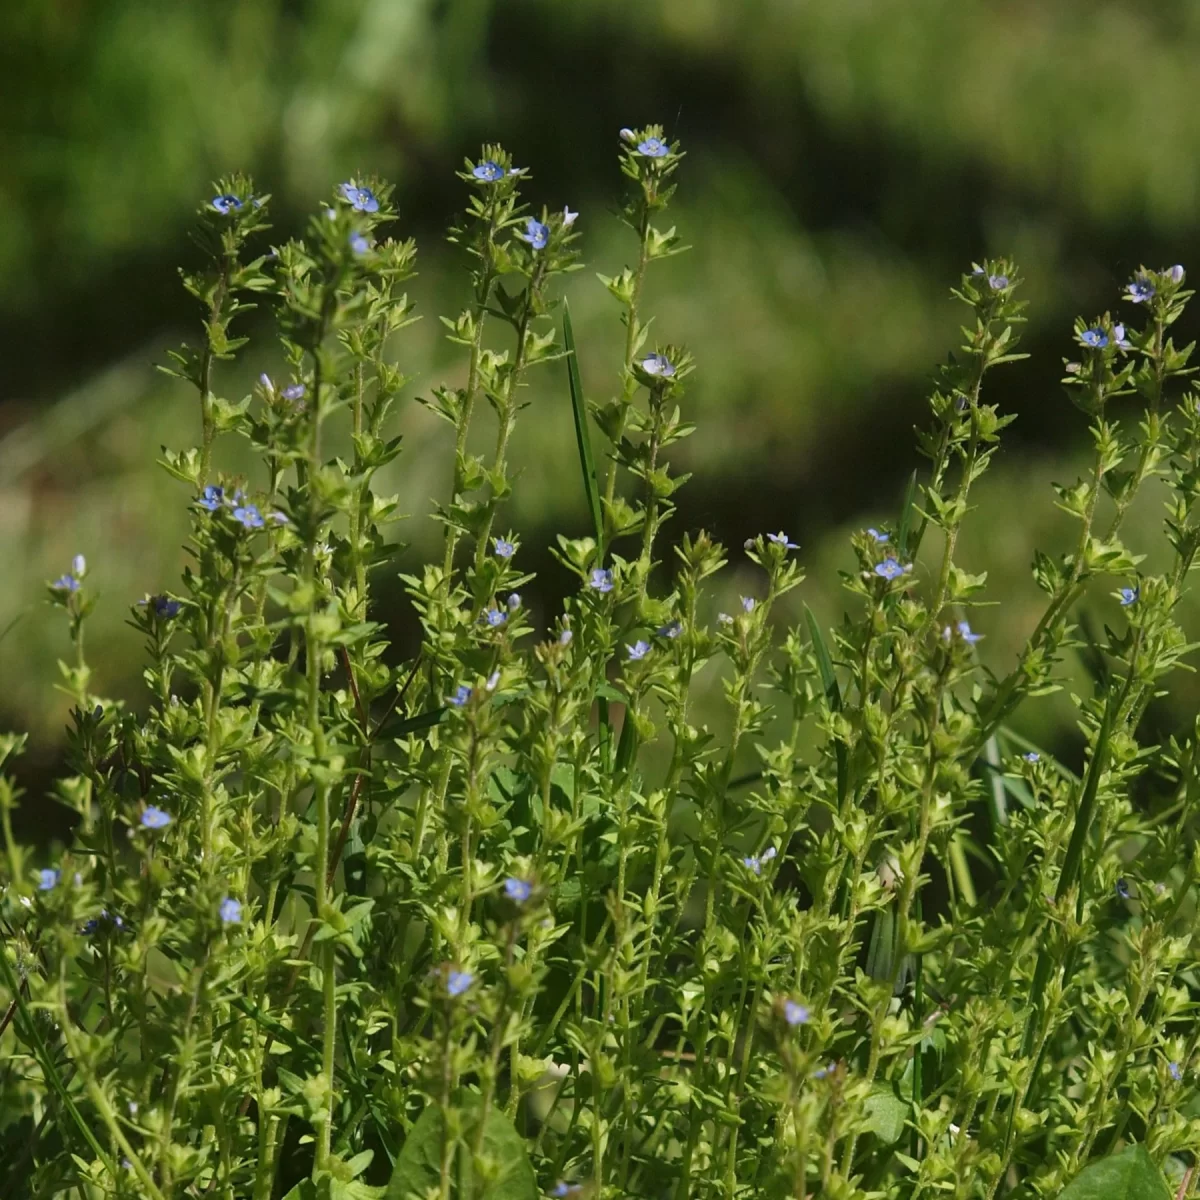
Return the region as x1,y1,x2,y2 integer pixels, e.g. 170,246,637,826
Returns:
0,127,1200,1200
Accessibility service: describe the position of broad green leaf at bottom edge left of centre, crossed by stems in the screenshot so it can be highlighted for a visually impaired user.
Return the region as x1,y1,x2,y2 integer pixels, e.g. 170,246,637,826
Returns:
385,1097,538,1200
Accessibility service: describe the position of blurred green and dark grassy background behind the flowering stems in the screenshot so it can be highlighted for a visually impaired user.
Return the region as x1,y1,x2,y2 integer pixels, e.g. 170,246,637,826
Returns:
0,0,1200,782
